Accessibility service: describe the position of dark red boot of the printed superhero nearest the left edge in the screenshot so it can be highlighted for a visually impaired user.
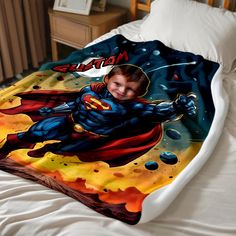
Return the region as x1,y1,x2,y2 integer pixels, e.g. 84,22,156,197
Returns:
0,134,35,159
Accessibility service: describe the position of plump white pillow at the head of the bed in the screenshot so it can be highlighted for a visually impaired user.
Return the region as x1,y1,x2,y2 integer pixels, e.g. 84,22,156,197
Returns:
140,0,236,72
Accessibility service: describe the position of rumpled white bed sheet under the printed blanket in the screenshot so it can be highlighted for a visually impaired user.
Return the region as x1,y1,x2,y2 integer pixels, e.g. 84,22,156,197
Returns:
0,21,236,236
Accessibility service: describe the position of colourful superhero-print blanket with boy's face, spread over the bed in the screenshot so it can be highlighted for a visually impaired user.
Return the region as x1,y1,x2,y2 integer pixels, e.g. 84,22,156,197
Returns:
0,35,222,224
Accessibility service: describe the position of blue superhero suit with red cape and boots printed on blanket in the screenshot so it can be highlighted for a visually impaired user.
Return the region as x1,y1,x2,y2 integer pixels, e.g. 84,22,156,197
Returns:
1,83,195,166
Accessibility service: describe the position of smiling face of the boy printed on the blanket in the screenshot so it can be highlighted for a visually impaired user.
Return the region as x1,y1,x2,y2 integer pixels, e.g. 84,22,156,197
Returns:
105,74,141,101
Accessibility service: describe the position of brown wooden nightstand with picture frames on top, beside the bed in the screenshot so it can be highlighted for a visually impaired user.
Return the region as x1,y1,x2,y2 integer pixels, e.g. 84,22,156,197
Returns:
48,5,128,61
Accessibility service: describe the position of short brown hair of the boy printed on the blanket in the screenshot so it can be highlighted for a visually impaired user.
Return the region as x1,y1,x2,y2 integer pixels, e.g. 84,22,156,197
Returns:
107,64,150,96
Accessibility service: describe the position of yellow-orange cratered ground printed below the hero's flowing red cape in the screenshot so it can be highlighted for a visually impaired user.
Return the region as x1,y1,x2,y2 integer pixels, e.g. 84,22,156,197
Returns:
7,140,201,199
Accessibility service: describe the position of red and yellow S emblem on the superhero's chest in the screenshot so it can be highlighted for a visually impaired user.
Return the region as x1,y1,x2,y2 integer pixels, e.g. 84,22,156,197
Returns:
83,94,111,111
